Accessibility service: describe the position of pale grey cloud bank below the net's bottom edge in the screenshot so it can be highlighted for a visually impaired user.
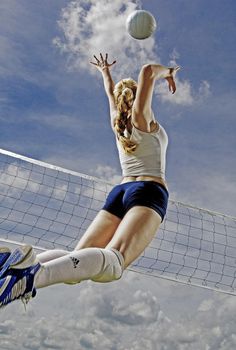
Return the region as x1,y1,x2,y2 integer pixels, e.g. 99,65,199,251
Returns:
0,273,236,350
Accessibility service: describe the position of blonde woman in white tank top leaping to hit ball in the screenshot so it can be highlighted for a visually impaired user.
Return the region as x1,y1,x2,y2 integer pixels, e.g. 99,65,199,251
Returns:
0,54,179,307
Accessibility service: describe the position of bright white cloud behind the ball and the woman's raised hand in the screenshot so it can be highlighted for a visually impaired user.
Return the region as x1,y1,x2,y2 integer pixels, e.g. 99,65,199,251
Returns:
53,0,157,79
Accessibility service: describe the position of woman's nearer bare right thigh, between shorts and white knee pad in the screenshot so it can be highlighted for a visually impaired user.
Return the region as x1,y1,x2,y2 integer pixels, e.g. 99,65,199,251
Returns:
107,206,161,267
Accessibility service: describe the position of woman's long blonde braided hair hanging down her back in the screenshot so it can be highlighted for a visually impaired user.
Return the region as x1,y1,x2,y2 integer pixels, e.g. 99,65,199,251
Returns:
113,78,137,153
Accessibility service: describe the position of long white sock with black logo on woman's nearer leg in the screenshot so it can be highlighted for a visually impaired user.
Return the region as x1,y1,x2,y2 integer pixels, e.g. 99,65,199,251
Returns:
35,248,124,288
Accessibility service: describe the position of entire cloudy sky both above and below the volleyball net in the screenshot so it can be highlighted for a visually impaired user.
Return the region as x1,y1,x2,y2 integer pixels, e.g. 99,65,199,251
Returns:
0,0,236,350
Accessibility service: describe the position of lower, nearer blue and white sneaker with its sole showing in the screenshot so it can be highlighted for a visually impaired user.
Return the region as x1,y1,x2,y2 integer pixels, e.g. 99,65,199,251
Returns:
0,263,41,308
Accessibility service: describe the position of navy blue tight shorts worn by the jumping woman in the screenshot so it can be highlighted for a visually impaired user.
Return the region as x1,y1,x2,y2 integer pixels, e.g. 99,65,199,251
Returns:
102,181,169,221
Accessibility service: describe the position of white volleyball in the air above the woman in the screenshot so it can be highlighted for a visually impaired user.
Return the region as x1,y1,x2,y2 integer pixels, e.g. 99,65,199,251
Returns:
126,10,157,40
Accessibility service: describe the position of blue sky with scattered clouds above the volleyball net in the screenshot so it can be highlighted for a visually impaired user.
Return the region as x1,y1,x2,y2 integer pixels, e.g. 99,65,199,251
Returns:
0,0,236,215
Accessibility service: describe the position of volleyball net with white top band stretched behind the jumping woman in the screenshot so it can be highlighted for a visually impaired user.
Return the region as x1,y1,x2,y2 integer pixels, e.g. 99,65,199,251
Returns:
0,149,236,295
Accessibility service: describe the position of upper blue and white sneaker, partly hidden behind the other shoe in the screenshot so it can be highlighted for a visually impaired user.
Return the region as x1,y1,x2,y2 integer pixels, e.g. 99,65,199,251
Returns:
0,245,35,278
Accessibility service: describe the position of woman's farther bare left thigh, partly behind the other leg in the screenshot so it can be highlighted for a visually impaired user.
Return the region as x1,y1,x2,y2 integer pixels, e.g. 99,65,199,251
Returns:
75,210,121,249
